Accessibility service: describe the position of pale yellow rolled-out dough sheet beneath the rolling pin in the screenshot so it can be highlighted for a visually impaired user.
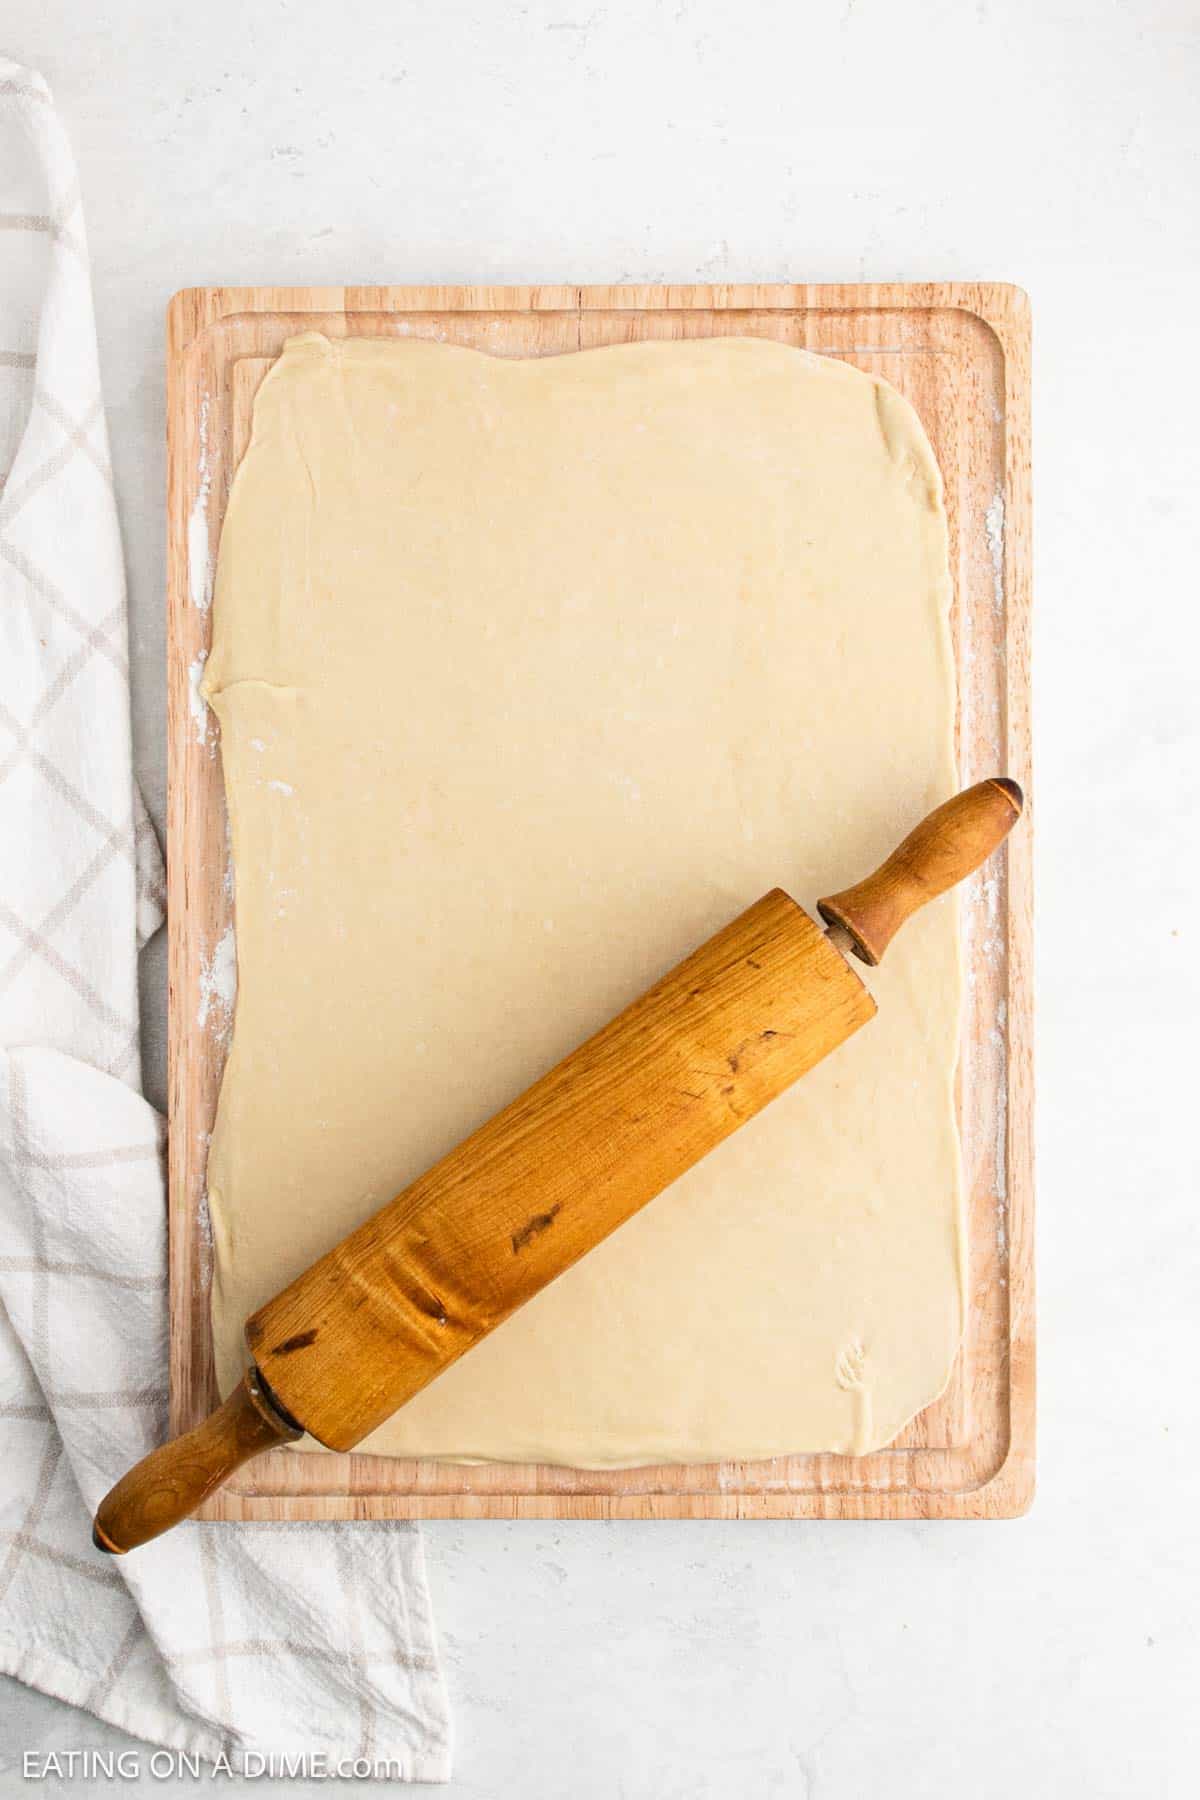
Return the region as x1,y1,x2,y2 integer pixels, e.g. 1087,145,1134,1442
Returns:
205,335,963,1467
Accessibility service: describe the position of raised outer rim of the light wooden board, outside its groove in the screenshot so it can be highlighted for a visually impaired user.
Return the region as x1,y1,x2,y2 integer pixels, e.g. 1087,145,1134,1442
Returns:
167,283,1036,1519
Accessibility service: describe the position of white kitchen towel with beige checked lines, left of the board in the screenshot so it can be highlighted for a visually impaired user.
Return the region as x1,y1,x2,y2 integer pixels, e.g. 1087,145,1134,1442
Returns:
0,59,450,1780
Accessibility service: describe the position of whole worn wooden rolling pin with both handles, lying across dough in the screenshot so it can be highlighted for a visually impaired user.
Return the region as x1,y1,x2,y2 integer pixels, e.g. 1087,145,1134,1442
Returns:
94,779,1024,1553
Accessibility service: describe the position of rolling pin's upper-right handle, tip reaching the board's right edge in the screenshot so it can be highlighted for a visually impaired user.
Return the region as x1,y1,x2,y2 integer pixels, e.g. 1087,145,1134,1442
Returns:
817,776,1025,967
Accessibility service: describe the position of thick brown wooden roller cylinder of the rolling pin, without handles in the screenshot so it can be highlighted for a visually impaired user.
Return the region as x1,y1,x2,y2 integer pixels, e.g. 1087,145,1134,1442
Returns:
246,889,874,1451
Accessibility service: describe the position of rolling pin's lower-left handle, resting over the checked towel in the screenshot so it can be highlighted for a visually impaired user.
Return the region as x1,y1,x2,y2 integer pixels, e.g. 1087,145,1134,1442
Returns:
92,1368,302,1557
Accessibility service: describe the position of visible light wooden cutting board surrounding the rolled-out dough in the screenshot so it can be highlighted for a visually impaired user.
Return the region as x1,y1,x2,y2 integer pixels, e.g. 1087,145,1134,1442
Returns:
167,283,1034,1519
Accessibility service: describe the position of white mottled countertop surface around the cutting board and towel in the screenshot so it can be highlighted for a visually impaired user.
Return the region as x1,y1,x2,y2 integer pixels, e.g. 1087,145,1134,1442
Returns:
0,0,1200,1800
